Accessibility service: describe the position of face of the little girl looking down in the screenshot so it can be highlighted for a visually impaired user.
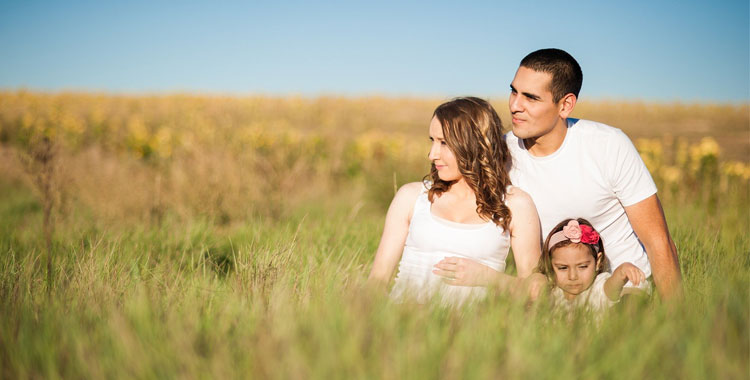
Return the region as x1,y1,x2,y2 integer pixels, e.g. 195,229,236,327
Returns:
551,244,596,300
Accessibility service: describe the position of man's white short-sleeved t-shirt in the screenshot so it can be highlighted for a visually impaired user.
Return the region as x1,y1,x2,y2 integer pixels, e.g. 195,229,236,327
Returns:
506,119,656,277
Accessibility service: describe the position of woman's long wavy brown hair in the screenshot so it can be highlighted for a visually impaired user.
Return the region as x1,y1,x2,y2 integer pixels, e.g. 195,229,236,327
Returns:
425,97,512,230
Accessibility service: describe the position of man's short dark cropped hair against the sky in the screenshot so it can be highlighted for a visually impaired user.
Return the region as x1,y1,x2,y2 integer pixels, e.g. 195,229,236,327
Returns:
521,49,583,103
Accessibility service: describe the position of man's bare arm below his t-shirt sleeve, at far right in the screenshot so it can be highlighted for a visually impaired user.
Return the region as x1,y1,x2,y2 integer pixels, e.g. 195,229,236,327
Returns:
625,194,682,300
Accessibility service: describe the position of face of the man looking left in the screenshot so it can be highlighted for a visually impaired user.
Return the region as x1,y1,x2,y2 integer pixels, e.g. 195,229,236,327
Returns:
508,66,560,139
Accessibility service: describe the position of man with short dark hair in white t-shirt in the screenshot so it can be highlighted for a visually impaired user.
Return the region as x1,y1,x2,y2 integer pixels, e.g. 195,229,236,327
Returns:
506,49,682,299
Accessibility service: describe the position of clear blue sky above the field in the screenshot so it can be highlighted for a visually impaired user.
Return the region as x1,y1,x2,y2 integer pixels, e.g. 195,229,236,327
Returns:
0,0,750,103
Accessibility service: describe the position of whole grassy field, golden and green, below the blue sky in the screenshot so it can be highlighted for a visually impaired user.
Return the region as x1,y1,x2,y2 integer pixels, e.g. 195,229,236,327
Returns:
0,92,750,379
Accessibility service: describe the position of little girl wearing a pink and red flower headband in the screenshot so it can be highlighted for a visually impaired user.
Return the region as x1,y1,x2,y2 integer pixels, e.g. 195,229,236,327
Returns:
539,218,646,311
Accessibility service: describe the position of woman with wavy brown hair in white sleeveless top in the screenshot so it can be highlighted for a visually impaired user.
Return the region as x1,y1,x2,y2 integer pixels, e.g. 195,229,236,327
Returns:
369,97,541,304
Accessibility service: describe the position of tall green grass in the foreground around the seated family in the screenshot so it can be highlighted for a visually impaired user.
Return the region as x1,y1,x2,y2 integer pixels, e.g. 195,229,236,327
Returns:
0,176,750,379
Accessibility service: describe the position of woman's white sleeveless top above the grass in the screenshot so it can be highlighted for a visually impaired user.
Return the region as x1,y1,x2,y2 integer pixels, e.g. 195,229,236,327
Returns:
391,184,510,305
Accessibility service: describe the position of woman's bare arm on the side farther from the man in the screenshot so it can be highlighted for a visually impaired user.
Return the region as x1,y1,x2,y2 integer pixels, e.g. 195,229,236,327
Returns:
367,182,424,287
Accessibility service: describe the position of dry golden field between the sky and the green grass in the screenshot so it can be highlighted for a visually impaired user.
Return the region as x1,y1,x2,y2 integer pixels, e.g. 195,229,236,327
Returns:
0,91,750,223
